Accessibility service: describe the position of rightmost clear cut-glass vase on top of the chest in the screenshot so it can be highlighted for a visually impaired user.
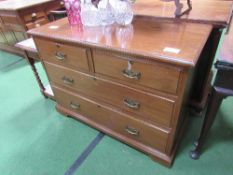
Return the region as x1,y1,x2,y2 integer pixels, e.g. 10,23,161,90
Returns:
113,0,133,25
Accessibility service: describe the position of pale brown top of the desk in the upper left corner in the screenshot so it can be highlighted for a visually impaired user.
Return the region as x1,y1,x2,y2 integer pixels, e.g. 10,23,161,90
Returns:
0,0,54,10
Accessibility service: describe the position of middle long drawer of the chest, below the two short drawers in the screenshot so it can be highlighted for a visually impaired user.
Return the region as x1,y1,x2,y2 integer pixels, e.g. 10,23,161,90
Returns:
45,63,175,127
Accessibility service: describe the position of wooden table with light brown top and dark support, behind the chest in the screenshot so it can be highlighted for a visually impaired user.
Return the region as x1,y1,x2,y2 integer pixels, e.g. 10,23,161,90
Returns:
134,0,233,112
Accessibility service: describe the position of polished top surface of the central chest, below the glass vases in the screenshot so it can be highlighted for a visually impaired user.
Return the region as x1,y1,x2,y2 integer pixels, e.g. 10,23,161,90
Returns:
28,17,212,67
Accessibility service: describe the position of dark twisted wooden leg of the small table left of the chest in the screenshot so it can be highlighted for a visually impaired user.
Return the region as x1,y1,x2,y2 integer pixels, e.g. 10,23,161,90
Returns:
25,52,48,98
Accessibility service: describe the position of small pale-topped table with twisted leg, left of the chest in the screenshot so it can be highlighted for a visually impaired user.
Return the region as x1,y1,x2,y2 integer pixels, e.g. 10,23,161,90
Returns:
15,38,54,100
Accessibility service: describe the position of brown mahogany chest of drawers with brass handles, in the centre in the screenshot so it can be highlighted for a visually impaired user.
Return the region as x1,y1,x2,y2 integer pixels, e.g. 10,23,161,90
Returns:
29,17,212,165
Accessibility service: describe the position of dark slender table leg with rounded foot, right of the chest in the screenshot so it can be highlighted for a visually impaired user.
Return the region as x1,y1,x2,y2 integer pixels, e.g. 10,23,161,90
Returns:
190,87,225,159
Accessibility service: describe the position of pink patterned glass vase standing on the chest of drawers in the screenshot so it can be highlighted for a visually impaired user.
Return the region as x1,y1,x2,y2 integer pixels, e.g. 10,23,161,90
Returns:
64,0,82,26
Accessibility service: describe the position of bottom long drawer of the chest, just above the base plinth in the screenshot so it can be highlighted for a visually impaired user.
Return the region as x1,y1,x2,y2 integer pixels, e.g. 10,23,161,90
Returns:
53,86,169,152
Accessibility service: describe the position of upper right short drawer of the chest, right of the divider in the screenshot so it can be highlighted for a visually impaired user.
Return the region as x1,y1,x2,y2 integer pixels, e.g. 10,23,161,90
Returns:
93,50,180,94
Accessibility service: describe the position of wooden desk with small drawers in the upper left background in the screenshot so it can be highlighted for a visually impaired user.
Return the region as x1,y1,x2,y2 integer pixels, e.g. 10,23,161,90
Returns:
0,0,63,55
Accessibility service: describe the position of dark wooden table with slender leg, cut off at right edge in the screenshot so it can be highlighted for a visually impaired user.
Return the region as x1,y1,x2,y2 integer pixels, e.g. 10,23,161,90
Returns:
190,19,233,159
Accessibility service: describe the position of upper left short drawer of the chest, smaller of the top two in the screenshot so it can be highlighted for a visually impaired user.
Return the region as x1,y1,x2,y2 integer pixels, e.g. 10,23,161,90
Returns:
34,38,89,70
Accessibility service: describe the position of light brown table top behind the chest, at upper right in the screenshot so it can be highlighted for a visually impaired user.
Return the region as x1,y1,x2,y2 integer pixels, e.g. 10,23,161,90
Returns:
134,0,233,26
